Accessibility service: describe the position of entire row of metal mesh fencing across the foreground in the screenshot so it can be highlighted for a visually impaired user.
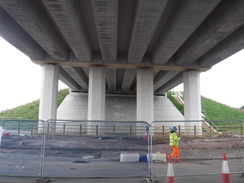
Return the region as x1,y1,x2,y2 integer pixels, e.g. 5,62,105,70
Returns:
0,120,244,182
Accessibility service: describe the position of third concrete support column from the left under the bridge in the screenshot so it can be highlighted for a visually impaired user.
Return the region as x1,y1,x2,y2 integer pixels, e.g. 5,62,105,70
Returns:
136,69,154,123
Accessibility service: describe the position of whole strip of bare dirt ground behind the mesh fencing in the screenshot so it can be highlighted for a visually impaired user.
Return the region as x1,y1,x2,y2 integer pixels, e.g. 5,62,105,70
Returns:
0,135,244,158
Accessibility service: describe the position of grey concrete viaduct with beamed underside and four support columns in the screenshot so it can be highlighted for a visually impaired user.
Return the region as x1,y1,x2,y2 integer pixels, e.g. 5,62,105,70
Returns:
0,0,244,125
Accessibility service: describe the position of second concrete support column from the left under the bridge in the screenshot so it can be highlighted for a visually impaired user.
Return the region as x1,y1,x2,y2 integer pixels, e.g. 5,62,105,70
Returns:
87,66,106,120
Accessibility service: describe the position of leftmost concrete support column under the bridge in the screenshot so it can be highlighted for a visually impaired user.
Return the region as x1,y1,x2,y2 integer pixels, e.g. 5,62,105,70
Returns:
39,64,59,121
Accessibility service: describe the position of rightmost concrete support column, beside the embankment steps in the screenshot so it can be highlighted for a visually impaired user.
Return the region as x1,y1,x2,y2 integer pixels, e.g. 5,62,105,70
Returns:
183,70,202,134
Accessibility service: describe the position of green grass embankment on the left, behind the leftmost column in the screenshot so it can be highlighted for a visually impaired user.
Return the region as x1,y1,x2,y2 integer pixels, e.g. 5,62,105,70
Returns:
0,89,69,119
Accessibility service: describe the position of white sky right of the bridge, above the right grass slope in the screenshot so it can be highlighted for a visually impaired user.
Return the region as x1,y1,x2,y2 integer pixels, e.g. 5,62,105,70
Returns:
172,49,244,108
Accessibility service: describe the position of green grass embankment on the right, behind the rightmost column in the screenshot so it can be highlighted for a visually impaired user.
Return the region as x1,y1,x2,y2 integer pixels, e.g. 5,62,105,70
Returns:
168,92,244,124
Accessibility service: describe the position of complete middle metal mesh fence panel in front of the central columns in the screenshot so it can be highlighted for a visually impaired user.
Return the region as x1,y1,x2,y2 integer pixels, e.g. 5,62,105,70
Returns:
43,120,149,178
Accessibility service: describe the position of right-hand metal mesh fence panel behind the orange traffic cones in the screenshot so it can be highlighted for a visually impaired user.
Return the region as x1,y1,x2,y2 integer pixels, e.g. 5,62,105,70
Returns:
150,120,244,180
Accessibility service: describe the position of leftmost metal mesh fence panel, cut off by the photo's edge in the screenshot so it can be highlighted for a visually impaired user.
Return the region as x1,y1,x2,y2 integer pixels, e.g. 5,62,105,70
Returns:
0,120,43,177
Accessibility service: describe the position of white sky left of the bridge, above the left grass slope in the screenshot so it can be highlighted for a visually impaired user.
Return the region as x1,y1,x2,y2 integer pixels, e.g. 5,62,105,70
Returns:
0,37,68,111
